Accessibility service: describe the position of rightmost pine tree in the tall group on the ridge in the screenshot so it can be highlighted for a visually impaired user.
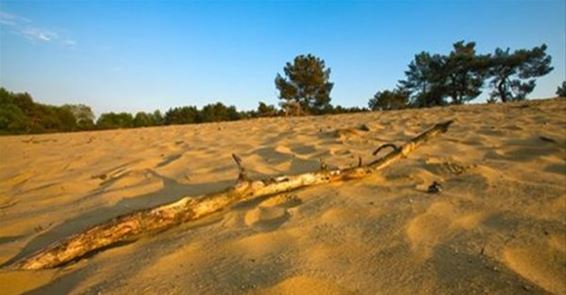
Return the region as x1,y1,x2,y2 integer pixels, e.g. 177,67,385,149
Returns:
488,44,553,102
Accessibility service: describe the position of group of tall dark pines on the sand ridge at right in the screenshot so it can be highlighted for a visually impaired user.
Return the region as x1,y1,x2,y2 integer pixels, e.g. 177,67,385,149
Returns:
368,41,561,110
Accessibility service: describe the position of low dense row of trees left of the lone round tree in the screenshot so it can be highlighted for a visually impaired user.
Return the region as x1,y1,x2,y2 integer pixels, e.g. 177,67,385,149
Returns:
0,88,278,134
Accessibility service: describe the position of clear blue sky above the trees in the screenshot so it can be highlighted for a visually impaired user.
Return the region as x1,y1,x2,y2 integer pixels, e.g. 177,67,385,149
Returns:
0,0,566,114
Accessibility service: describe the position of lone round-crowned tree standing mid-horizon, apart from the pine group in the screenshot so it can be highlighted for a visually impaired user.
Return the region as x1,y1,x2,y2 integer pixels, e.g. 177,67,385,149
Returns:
275,54,334,114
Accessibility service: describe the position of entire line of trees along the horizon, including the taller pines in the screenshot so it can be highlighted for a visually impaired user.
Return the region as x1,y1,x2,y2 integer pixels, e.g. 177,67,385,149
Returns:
0,41,566,134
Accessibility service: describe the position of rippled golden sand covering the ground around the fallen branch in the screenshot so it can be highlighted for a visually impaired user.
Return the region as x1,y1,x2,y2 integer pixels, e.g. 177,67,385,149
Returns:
0,100,566,294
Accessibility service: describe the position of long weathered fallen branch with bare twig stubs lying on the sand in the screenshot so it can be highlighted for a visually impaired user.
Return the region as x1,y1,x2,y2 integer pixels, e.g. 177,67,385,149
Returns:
10,121,453,270
